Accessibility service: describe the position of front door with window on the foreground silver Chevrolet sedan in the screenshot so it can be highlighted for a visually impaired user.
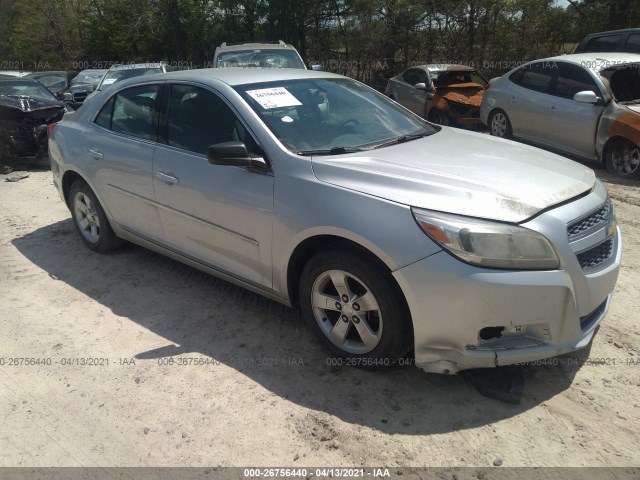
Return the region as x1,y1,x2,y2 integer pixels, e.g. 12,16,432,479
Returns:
153,83,274,287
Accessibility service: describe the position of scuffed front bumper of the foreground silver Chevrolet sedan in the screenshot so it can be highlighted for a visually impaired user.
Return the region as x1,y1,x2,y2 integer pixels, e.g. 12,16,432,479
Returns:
393,186,622,373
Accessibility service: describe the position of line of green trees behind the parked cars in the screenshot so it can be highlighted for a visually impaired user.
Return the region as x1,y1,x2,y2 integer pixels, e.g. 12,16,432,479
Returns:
0,0,640,88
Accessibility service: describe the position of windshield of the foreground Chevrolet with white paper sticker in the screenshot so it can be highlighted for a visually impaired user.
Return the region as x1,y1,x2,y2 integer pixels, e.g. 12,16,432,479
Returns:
236,78,437,155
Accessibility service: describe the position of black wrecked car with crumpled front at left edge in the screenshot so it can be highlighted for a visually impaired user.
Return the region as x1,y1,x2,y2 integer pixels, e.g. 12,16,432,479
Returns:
0,78,66,171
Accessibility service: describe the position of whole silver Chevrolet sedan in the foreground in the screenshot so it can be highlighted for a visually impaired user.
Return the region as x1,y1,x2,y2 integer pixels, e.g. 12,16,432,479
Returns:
49,68,621,373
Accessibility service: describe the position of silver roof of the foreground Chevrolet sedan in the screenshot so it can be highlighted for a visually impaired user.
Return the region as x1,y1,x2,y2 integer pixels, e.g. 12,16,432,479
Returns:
124,67,346,86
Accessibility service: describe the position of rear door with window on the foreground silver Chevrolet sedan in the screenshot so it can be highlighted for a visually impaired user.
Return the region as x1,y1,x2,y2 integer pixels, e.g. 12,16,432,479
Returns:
83,83,162,240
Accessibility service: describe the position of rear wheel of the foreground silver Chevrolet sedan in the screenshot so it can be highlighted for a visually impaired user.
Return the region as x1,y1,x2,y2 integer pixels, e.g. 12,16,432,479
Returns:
69,180,124,253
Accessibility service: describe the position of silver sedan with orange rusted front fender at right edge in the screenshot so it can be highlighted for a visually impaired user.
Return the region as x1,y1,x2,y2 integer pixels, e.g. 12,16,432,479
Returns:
480,53,640,179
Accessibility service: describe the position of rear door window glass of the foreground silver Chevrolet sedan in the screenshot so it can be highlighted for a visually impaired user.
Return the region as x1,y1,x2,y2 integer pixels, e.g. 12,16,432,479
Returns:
95,85,160,140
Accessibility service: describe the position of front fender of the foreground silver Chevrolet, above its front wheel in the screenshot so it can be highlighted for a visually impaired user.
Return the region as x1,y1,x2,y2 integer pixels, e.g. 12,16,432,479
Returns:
273,155,441,296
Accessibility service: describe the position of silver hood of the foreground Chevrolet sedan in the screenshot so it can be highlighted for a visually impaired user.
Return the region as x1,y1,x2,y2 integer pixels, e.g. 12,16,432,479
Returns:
312,128,595,223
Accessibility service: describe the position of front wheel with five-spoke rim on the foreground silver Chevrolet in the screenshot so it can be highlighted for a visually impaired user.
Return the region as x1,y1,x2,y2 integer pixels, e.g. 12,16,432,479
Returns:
299,250,413,368
